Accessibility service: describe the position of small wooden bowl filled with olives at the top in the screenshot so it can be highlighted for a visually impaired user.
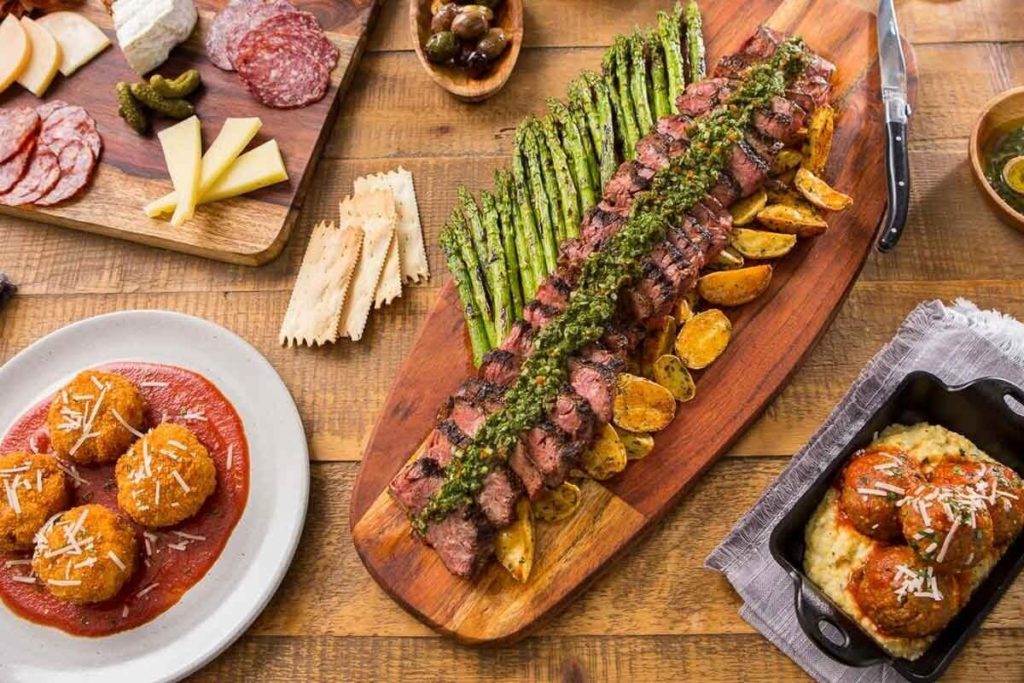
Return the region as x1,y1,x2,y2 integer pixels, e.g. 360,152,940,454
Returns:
410,0,522,102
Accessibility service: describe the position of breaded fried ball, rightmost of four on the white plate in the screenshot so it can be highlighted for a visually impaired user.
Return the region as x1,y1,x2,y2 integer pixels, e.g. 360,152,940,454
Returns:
116,422,217,527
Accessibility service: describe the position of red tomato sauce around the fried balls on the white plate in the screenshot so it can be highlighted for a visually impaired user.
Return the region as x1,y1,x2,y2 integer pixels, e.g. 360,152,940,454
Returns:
0,362,249,637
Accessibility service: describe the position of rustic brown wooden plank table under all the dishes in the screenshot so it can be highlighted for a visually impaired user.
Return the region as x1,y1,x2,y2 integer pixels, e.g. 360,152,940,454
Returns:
0,0,1024,683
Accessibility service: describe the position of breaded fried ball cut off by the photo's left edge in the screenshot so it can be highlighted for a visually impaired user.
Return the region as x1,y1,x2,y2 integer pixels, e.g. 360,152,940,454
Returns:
0,453,68,553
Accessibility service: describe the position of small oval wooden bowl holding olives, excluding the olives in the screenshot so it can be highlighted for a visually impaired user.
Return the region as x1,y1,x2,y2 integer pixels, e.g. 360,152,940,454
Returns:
409,0,522,102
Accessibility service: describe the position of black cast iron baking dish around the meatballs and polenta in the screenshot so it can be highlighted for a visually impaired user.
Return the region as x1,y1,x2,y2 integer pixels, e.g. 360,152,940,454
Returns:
769,372,1024,681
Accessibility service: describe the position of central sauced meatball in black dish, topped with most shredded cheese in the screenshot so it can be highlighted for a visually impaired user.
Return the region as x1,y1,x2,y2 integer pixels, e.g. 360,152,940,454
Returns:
900,484,992,572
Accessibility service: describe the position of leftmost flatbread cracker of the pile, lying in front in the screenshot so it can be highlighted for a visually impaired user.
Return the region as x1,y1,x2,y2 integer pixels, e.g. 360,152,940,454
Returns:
281,221,362,346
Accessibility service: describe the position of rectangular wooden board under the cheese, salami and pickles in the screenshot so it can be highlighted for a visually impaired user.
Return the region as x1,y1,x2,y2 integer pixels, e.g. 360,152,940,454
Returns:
0,0,380,265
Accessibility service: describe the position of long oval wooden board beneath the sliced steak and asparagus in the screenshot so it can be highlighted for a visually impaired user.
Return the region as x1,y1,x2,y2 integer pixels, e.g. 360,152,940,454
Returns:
351,0,914,643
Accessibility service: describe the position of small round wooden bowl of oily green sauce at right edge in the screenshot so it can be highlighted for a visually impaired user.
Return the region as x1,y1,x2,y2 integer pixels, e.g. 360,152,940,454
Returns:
970,87,1024,230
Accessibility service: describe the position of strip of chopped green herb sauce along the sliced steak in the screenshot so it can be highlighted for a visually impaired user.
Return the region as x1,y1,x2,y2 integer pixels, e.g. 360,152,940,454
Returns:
413,38,807,533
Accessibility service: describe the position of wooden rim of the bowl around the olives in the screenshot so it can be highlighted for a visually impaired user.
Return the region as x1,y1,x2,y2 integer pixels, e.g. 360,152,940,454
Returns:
409,0,525,102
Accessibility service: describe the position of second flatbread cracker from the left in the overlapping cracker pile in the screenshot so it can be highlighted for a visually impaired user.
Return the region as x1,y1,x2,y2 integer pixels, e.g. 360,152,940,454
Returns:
339,190,397,341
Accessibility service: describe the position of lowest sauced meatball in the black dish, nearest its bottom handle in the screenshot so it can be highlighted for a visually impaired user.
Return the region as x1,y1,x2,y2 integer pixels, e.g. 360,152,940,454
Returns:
849,546,962,638
